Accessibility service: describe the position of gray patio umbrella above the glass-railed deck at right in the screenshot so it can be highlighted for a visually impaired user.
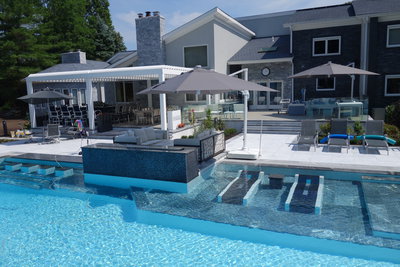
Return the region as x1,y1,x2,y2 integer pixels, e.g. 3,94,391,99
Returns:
288,61,379,99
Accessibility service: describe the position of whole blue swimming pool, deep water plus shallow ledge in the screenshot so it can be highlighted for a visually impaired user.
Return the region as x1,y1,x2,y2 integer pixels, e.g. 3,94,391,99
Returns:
0,159,400,266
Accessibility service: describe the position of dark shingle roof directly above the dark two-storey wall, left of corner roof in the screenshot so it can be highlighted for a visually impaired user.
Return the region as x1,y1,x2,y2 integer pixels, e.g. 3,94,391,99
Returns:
288,4,355,23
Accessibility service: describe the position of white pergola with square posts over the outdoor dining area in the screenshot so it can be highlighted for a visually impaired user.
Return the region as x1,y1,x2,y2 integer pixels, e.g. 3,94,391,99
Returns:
25,65,192,130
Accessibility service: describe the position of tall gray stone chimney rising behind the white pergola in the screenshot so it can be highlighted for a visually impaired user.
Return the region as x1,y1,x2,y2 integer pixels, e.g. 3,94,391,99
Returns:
135,11,165,66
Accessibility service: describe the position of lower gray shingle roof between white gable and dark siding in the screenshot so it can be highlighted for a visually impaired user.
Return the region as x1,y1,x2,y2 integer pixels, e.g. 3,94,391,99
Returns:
229,35,292,62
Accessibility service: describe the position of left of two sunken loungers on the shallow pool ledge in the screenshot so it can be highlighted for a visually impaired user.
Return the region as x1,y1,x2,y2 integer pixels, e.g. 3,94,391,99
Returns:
217,170,264,205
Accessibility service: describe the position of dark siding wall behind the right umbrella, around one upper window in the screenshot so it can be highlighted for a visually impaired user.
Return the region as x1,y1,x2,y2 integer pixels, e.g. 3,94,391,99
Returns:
293,25,361,100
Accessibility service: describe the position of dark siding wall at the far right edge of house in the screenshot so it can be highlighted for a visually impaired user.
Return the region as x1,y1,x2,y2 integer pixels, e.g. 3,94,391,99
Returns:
367,18,400,108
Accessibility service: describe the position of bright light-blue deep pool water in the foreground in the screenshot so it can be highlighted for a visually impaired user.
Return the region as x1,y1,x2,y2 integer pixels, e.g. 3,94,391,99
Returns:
0,184,393,266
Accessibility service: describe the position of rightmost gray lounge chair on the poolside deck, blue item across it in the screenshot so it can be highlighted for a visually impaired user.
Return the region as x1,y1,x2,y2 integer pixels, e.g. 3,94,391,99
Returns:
363,120,389,155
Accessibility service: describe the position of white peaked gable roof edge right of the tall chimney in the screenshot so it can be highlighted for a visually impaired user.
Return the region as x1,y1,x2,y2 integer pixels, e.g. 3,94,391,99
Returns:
163,7,255,43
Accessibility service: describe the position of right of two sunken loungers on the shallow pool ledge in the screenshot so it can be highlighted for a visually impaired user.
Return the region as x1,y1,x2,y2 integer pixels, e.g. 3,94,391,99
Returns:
285,174,324,215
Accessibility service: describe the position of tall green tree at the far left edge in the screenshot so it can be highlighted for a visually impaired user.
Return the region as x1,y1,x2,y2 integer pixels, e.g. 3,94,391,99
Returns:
0,0,54,109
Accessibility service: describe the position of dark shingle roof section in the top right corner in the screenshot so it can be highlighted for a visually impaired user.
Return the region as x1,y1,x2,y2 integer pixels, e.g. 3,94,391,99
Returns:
353,0,400,16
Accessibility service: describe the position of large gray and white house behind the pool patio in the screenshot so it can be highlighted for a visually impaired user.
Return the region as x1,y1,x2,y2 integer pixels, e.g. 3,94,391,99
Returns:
25,0,400,130
